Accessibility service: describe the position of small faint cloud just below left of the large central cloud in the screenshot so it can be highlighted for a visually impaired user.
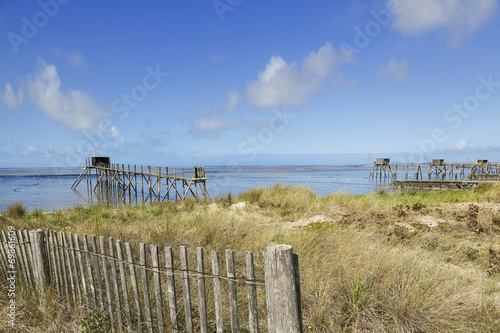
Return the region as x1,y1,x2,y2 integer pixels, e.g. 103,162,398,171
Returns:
191,110,242,137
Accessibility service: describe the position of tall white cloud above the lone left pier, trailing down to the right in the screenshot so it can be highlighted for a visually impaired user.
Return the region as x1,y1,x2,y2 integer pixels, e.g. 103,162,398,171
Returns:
27,59,111,131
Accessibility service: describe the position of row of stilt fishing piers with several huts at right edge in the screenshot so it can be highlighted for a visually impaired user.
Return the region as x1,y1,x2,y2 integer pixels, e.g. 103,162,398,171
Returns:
370,158,500,189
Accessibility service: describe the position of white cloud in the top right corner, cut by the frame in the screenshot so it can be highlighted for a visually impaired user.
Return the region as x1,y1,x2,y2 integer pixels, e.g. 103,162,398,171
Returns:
388,0,498,47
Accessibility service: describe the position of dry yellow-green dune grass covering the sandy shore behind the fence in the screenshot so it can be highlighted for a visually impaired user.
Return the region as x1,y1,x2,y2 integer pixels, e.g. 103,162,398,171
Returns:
0,184,500,332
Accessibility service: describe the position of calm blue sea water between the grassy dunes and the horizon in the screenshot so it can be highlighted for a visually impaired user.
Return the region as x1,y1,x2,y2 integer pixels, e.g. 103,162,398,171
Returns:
0,166,389,211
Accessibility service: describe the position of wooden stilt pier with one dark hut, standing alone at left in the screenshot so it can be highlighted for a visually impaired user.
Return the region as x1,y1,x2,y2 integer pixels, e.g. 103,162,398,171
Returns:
71,157,210,205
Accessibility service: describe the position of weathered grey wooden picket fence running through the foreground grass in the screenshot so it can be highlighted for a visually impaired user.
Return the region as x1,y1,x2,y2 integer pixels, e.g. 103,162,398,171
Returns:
0,227,303,333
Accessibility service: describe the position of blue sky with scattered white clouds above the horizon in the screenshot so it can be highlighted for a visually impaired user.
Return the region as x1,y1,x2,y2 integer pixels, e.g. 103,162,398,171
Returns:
0,0,500,167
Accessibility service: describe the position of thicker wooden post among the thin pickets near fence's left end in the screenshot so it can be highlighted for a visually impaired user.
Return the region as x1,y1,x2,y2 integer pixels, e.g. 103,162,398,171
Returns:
30,229,50,294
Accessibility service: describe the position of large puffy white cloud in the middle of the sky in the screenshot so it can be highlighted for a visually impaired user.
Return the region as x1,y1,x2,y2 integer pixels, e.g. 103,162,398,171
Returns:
247,43,345,108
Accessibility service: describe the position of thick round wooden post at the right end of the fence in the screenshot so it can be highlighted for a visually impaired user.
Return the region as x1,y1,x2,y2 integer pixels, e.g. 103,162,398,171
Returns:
264,245,302,333
